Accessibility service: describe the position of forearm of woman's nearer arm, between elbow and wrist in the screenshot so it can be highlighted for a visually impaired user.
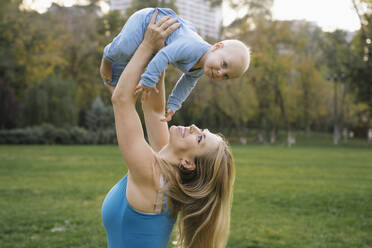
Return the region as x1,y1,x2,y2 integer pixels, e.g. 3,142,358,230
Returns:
111,42,154,106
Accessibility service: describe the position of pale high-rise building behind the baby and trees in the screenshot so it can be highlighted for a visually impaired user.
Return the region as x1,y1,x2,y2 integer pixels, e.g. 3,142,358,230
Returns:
110,0,222,39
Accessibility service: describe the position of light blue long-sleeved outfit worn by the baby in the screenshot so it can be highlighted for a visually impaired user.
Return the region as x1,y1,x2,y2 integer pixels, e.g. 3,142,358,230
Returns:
104,8,211,112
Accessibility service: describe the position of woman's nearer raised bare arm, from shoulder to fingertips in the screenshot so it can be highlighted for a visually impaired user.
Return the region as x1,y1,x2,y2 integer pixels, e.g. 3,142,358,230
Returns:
111,12,179,181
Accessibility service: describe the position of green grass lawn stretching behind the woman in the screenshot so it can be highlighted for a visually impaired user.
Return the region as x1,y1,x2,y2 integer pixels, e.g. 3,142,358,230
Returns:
0,144,372,248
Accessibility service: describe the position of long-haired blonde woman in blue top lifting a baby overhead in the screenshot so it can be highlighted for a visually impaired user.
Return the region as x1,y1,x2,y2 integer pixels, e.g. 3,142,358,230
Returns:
102,10,234,248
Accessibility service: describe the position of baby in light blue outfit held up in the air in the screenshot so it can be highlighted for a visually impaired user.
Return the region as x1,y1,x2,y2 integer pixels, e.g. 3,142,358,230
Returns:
101,8,250,121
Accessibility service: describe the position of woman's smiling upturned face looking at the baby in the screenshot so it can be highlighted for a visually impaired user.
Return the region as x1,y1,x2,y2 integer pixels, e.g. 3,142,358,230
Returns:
169,125,222,159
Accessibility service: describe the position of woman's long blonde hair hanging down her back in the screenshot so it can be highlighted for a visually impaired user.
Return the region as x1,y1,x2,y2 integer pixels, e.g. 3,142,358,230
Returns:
155,136,235,248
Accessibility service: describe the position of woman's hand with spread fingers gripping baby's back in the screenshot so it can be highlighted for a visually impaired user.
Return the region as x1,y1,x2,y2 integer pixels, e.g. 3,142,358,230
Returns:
142,9,181,52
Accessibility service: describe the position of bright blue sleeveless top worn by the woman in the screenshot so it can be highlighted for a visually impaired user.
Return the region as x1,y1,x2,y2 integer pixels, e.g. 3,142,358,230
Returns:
102,175,176,248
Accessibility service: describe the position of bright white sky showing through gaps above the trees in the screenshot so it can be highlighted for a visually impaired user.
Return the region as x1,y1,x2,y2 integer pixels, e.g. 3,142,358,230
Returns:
24,0,360,31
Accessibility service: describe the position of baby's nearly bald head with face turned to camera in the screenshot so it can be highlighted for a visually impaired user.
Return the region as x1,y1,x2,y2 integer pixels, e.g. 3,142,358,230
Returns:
203,40,250,82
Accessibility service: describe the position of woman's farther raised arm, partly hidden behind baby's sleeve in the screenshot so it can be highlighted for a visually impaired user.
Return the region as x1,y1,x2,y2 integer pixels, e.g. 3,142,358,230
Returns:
142,71,169,152
